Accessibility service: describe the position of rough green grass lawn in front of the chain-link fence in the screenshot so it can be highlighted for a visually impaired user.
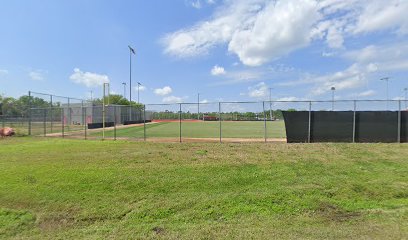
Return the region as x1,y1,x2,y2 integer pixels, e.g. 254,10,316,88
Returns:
0,138,408,239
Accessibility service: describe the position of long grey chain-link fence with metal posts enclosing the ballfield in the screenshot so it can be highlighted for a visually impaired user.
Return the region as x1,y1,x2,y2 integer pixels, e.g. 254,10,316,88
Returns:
5,100,407,142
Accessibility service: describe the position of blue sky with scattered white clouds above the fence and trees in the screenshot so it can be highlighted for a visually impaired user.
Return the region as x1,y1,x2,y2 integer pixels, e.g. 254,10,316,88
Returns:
0,0,408,103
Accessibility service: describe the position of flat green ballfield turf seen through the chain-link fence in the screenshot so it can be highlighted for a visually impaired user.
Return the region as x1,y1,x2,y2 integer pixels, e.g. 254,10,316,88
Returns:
91,121,286,138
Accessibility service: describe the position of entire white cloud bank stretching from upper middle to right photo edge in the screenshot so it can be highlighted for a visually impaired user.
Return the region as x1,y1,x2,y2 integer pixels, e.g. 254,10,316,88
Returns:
162,0,408,66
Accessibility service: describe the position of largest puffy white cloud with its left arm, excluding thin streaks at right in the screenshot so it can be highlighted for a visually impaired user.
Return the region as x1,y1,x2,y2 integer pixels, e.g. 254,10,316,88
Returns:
163,0,319,66
